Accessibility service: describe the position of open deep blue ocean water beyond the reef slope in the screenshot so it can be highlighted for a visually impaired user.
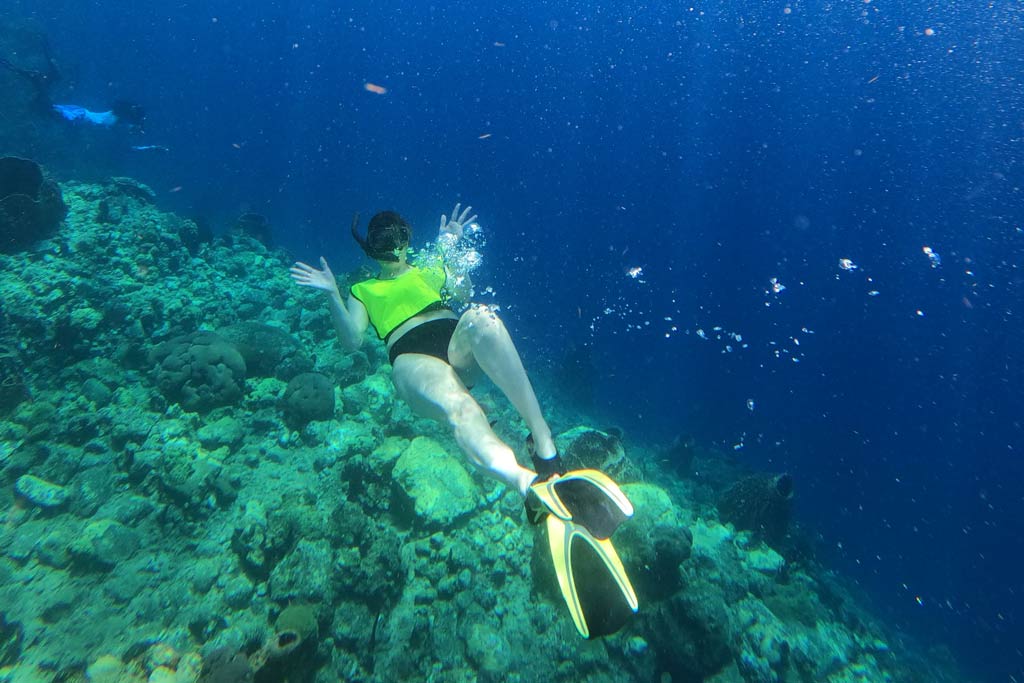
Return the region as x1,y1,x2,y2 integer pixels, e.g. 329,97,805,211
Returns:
7,0,1024,681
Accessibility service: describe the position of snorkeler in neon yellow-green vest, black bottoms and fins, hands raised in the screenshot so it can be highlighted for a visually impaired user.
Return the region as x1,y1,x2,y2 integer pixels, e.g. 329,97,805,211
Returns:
291,204,637,638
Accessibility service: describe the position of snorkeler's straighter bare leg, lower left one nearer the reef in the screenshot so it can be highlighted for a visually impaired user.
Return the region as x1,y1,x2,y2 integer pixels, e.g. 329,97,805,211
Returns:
391,353,537,496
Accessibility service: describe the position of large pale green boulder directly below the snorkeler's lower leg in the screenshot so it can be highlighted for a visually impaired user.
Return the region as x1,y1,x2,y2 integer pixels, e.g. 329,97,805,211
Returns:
392,436,480,525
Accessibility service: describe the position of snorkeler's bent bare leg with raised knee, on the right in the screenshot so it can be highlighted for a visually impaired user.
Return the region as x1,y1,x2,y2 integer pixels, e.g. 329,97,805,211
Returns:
449,305,555,458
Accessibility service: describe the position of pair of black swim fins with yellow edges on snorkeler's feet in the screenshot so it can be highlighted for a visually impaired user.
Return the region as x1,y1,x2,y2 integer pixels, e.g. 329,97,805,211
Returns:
526,470,639,638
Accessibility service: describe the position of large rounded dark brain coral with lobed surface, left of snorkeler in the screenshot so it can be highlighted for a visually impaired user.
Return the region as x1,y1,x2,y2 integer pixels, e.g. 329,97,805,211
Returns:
150,332,246,413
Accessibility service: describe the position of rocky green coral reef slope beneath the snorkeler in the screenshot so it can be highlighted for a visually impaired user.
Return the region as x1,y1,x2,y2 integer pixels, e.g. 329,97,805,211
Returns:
0,182,959,683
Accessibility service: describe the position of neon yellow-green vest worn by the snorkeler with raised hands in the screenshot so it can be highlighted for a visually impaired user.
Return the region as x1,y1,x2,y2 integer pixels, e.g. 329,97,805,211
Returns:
349,265,445,339
